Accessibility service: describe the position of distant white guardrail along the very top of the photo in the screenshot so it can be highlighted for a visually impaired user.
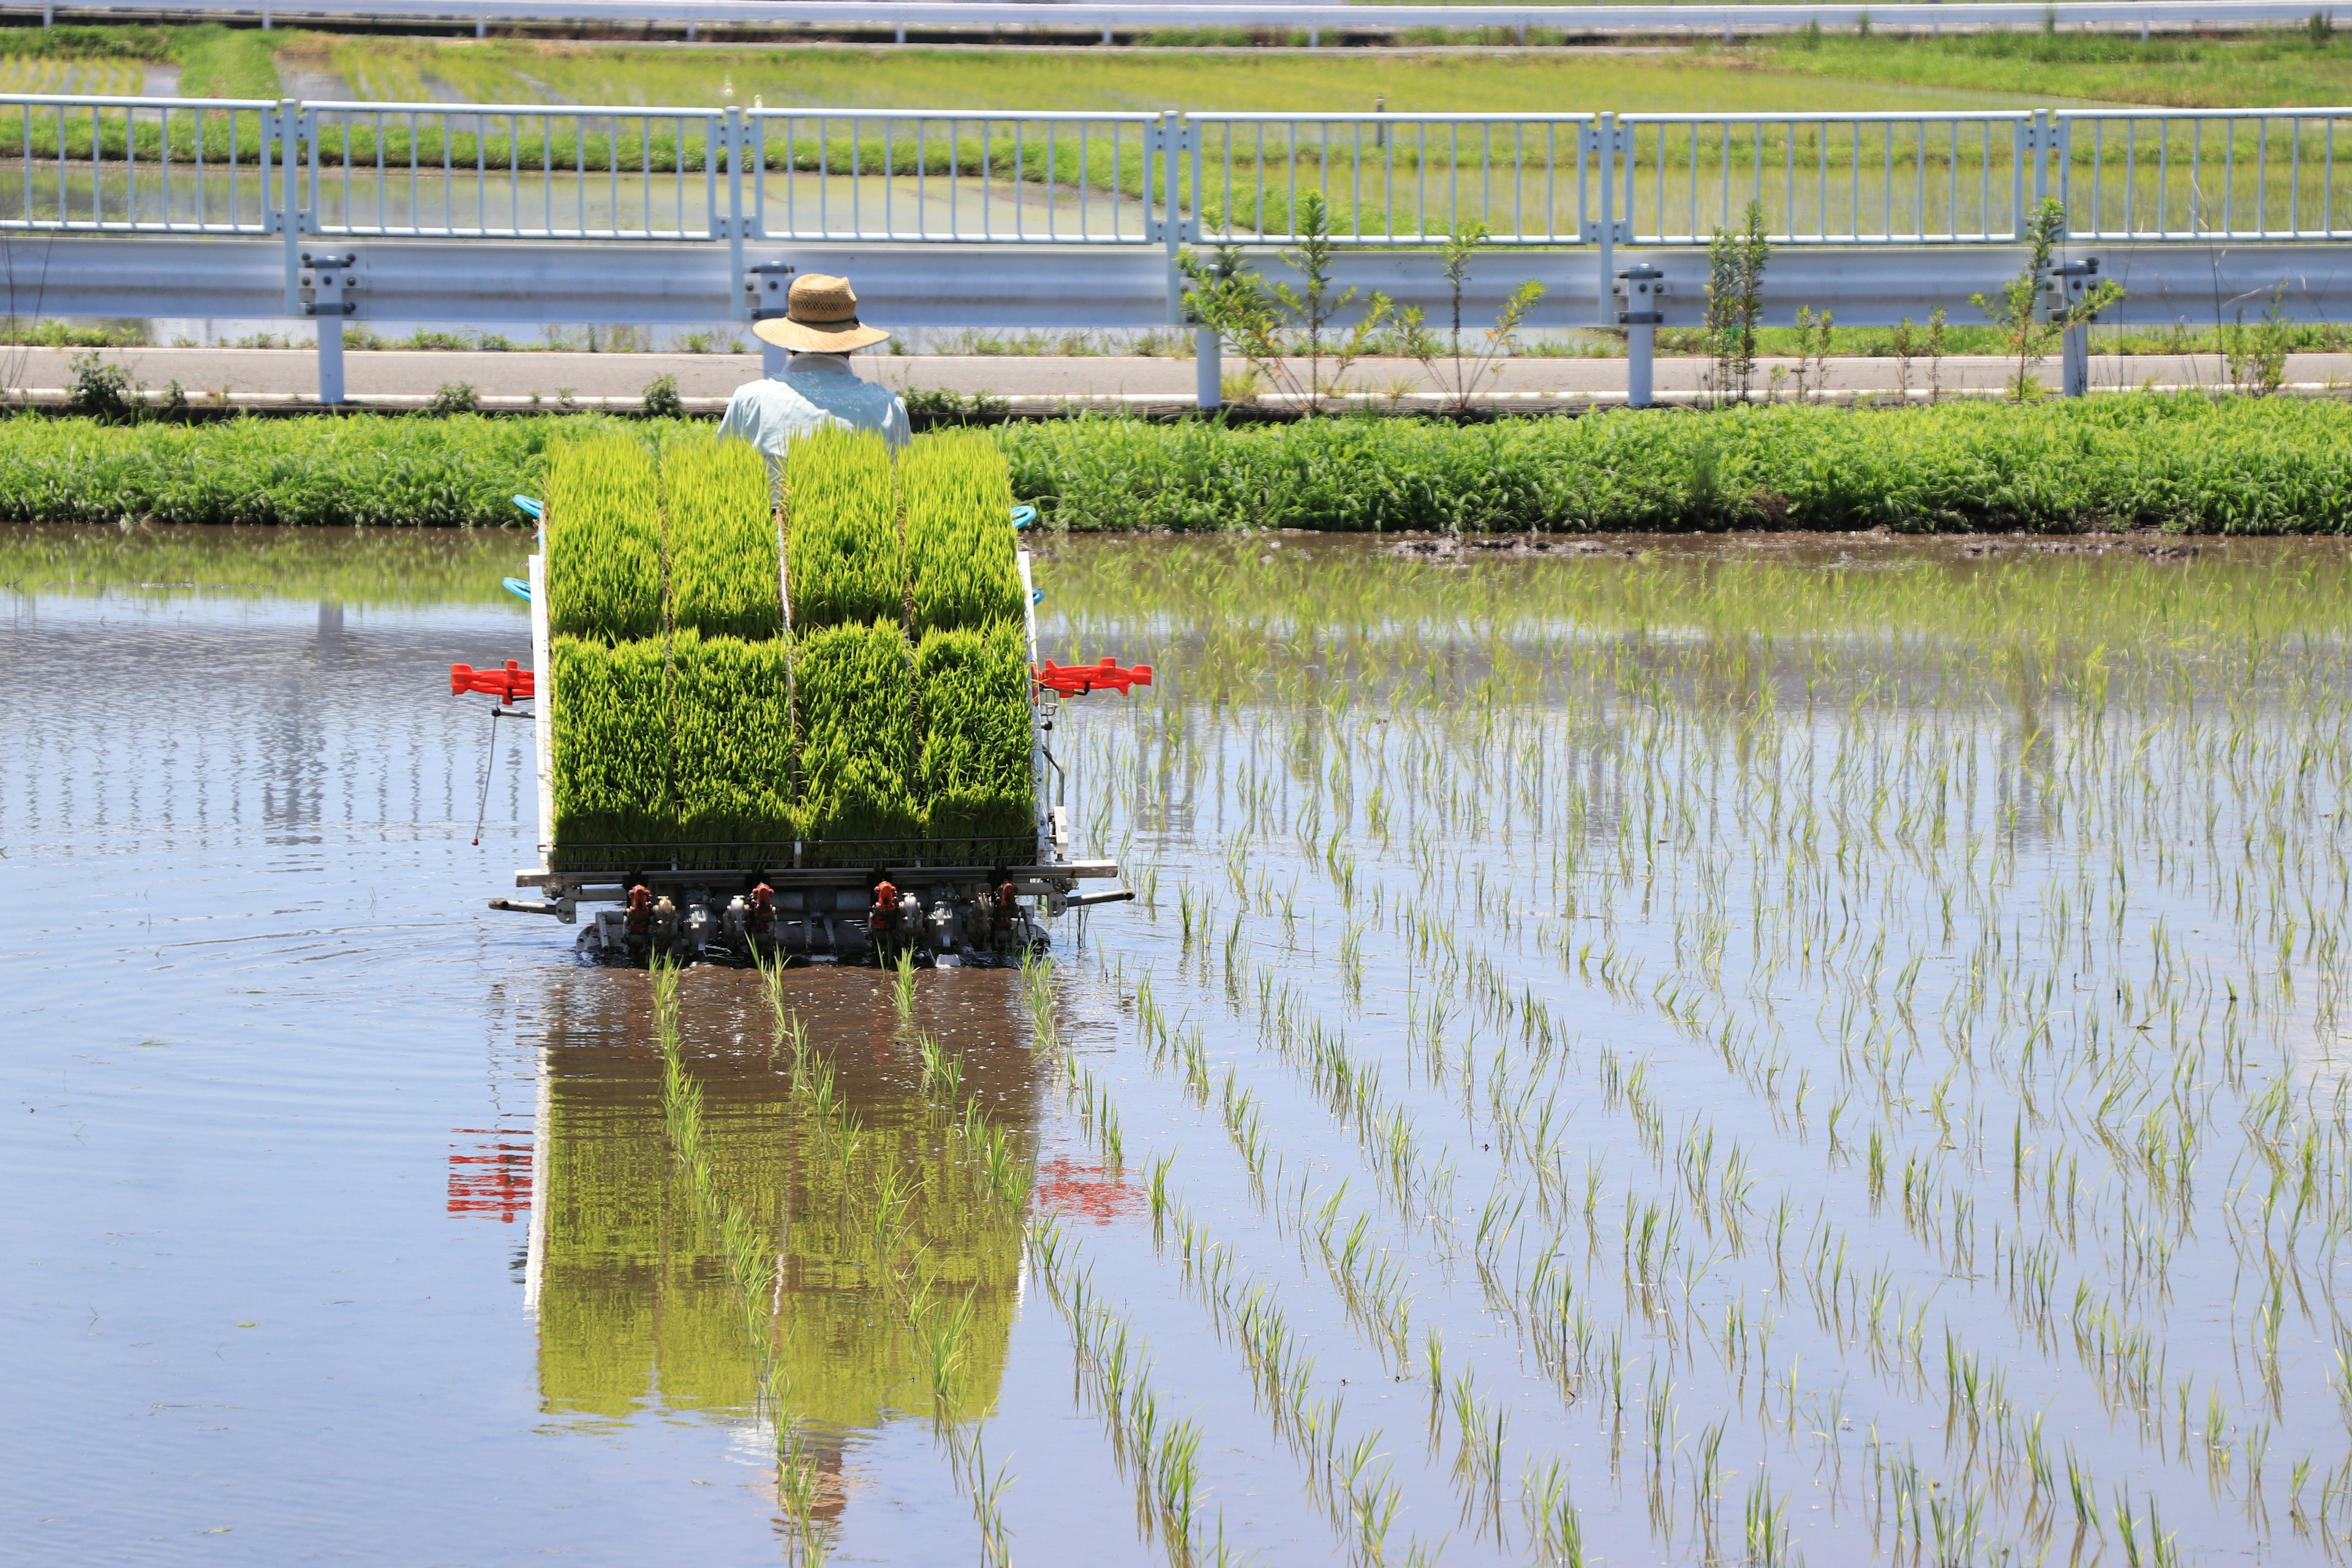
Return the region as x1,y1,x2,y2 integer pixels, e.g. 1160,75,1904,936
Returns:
0,0,2343,42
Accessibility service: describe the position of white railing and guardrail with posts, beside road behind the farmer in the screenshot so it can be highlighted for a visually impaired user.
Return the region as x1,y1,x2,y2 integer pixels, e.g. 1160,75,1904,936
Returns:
0,96,2352,402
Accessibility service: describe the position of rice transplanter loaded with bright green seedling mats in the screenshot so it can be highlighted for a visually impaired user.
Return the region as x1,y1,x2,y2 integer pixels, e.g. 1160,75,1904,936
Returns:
501,435,1117,962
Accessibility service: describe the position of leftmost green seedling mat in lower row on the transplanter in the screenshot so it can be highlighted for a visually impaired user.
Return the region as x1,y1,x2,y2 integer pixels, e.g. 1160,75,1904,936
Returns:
552,637,677,867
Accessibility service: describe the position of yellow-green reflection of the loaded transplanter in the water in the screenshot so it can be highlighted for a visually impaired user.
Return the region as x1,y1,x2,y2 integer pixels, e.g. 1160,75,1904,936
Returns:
529,968,1039,1466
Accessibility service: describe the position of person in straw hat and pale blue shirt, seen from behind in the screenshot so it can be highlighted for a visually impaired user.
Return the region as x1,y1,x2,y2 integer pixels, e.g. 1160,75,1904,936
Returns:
720,273,908,466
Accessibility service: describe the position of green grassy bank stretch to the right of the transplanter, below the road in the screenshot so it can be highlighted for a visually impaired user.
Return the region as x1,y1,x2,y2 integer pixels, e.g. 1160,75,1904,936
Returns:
995,393,2352,533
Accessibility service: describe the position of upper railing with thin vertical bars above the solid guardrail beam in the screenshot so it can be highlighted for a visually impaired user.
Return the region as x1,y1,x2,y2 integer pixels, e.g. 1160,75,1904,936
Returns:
0,96,2352,247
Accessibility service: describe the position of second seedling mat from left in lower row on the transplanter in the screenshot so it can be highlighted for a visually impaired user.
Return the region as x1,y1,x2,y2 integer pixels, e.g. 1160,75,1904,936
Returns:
668,630,795,844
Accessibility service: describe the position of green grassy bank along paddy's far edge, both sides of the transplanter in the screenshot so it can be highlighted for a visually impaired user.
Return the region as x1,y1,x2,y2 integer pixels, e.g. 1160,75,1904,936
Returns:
0,393,2352,540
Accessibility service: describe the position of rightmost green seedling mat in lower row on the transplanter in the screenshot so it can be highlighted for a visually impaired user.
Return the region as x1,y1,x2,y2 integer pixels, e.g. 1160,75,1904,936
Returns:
915,620,1035,858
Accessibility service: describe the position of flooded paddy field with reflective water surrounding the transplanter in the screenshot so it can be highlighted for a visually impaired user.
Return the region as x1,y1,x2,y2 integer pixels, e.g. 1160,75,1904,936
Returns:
0,531,2352,1566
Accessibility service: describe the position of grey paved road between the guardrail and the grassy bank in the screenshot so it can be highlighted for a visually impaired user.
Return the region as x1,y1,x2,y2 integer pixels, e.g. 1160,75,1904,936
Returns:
0,348,2352,409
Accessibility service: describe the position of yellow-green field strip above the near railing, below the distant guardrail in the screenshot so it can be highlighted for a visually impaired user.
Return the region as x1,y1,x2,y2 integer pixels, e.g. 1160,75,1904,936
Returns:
312,31,2352,113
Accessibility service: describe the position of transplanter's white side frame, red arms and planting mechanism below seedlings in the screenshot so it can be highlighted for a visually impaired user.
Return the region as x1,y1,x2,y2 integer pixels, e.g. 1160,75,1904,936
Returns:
466,499,1153,964
